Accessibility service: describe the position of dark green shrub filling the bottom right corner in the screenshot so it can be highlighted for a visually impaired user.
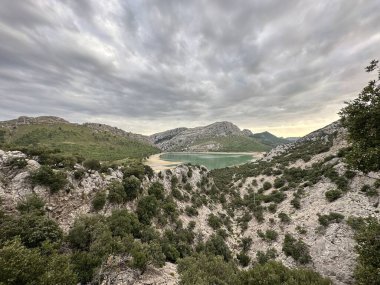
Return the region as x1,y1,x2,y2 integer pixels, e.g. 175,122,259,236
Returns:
354,218,380,285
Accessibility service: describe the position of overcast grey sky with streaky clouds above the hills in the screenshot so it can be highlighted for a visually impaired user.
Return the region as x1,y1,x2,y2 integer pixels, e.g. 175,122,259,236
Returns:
0,0,380,136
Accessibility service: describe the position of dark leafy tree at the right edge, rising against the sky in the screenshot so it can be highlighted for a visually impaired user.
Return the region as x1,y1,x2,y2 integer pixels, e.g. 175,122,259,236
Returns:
339,60,380,172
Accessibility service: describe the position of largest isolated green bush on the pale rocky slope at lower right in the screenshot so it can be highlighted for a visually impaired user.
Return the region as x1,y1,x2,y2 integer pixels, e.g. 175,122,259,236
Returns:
282,234,311,264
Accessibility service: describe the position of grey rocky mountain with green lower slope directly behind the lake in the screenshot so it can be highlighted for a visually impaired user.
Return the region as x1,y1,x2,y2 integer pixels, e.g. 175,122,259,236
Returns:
150,122,270,151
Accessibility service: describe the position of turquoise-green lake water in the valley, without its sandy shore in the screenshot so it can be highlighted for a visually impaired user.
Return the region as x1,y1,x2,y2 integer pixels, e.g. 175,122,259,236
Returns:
160,152,255,170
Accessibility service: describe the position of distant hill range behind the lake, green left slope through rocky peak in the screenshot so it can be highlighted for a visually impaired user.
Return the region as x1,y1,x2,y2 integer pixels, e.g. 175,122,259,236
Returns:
0,116,292,159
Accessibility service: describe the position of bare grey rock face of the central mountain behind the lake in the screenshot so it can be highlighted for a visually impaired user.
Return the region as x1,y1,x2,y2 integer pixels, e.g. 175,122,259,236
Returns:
150,122,252,151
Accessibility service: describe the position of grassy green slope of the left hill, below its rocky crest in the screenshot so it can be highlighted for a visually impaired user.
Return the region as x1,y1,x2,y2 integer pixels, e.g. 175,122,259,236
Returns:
0,123,159,161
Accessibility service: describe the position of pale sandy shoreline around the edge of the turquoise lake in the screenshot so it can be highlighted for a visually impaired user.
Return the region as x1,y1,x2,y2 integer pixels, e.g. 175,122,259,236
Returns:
144,152,265,171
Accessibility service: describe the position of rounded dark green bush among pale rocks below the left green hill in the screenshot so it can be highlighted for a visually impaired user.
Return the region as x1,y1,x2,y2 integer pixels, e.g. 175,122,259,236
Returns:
30,165,67,193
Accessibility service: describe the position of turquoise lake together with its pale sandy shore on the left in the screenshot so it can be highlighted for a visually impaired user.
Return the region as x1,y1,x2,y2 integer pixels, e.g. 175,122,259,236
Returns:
147,152,260,170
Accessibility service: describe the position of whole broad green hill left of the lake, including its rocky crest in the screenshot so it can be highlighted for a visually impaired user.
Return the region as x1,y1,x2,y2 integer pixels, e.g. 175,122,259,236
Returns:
0,117,159,161
